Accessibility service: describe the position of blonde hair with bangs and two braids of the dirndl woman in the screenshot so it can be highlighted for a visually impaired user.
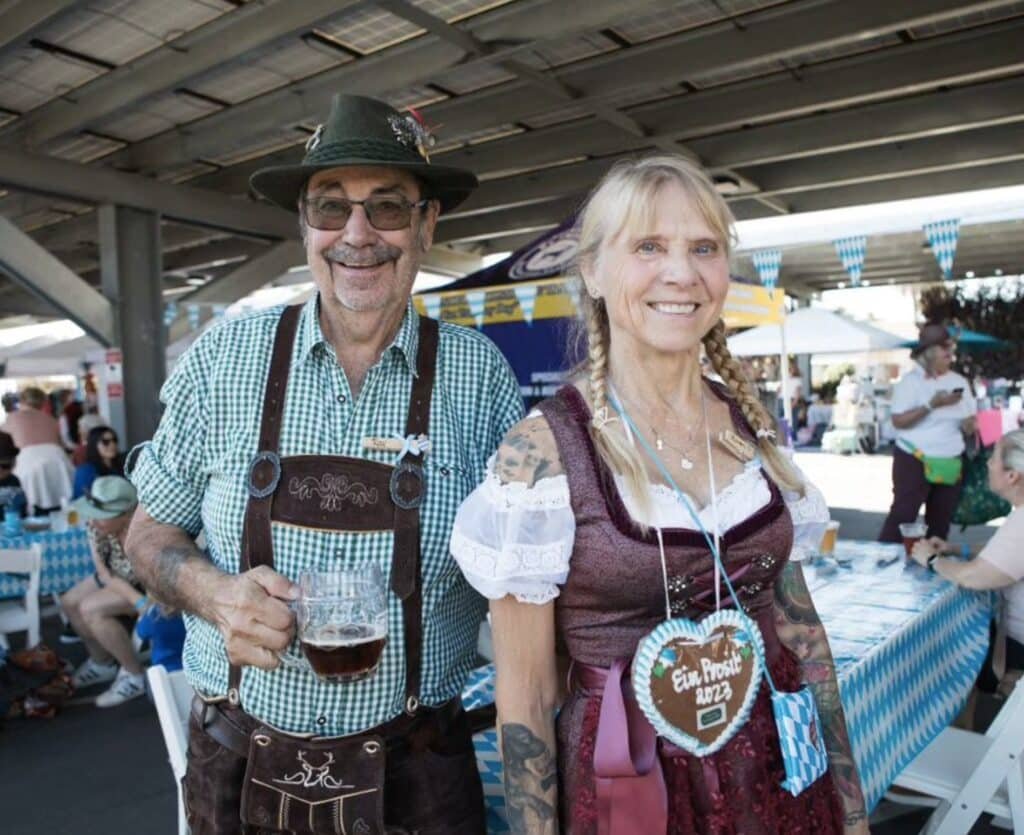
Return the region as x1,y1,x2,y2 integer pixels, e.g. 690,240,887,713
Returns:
575,155,804,497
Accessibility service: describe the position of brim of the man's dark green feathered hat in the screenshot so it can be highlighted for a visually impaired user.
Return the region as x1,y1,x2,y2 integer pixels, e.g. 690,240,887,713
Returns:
249,159,479,213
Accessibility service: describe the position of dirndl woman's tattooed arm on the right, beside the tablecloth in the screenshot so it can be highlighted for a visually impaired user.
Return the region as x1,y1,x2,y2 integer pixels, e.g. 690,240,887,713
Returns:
775,562,867,826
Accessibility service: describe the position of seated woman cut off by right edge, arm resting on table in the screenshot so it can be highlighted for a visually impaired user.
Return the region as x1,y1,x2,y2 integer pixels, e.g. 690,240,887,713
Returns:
911,429,1024,693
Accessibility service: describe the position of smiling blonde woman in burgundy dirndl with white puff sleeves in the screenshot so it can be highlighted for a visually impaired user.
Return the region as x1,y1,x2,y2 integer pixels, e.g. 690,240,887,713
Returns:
452,157,867,835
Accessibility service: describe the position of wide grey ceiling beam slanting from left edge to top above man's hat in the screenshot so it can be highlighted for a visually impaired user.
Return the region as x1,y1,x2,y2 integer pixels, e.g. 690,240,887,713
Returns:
4,0,362,148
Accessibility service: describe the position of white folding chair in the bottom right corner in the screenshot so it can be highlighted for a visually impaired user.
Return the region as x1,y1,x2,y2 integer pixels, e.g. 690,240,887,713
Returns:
886,683,1024,835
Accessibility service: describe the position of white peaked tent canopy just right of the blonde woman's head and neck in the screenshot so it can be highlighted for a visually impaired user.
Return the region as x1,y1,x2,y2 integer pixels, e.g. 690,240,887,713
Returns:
729,307,906,357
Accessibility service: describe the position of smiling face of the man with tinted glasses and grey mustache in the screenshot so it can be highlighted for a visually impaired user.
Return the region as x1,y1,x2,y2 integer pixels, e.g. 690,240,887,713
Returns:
305,166,437,312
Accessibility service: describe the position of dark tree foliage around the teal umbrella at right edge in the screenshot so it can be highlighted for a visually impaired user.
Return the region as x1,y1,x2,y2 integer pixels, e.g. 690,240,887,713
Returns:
921,280,1024,380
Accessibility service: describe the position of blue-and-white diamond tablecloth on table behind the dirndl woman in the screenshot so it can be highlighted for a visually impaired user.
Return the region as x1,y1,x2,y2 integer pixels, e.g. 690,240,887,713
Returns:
463,540,991,833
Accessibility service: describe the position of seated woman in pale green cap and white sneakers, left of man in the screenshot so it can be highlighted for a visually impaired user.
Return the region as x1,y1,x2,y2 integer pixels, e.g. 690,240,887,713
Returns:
60,475,148,707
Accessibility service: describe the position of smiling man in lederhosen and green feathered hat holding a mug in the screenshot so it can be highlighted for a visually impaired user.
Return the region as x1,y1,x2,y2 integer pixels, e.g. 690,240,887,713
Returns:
128,95,522,835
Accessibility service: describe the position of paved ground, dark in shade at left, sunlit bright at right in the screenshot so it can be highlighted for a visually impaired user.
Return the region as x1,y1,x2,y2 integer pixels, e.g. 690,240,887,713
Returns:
0,453,1002,835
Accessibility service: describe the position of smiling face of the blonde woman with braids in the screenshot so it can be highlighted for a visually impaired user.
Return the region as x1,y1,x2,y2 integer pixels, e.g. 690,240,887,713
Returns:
584,182,729,354
